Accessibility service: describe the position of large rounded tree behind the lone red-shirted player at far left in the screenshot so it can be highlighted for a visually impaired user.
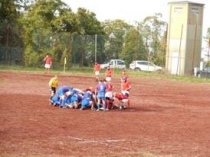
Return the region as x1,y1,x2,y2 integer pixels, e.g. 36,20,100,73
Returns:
20,0,78,66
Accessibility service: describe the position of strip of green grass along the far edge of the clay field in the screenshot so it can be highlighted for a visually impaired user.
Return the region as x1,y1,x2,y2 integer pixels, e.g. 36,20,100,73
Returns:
0,65,210,83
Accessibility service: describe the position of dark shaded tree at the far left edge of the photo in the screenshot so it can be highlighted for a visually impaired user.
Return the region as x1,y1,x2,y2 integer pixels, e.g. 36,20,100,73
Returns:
0,0,22,64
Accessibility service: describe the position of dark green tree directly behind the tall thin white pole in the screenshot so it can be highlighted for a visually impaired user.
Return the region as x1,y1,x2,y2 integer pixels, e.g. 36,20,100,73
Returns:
73,8,105,66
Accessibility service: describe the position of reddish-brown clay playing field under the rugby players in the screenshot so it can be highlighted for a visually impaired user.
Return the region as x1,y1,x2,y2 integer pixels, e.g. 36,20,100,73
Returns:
0,71,210,157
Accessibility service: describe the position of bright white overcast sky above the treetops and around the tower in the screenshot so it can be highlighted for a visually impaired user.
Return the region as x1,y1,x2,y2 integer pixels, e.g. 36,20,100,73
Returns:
62,0,210,48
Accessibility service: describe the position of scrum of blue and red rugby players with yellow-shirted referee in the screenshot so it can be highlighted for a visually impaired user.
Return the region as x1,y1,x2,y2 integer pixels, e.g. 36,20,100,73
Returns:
49,71,131,111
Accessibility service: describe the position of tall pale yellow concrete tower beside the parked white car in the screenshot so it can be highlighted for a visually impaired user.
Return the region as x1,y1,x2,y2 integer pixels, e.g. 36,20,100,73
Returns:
166,1,204,75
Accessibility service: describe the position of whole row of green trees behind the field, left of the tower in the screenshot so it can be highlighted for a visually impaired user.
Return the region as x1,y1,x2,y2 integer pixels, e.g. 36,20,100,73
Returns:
0,0,208,67
